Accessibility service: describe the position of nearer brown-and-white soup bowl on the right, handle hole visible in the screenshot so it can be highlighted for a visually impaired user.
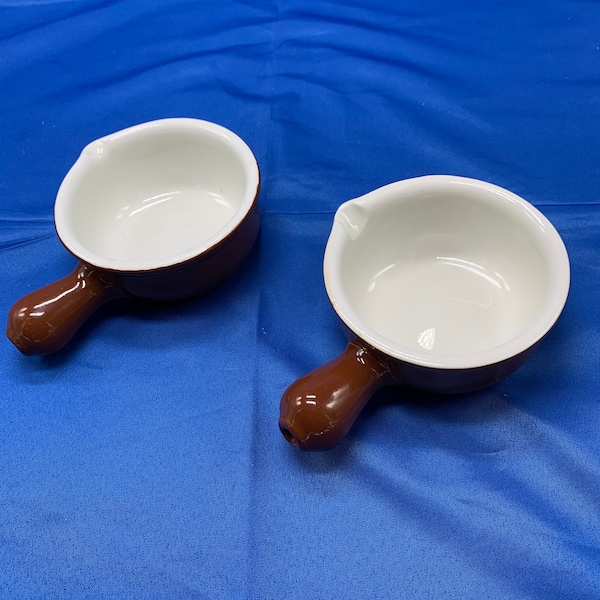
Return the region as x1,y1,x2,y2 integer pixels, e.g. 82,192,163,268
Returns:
279,175,570,450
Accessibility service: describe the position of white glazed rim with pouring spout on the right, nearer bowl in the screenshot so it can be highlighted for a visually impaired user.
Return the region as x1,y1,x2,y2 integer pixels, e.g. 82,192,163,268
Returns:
323,175,570,369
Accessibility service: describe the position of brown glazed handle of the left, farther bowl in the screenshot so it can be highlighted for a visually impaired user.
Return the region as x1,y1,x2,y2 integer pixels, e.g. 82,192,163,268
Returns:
6,263,126,355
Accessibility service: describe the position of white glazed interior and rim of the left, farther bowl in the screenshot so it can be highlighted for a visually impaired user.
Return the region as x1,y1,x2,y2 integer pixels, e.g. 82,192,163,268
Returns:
55,119,258,271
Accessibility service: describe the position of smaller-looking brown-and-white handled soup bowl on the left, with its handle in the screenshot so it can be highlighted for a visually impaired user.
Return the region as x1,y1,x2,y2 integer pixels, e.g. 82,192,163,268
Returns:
6,118,260,354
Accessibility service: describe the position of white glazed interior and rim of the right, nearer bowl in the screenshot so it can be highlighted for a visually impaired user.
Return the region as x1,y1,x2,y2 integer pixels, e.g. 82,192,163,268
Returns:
325,176,568,368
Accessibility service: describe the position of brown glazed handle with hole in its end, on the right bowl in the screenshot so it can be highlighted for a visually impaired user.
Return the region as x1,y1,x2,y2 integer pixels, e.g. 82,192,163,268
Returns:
279,342,395,450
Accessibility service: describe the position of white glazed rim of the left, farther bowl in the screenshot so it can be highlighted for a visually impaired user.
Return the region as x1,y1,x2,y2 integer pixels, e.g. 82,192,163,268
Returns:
54,117,260,272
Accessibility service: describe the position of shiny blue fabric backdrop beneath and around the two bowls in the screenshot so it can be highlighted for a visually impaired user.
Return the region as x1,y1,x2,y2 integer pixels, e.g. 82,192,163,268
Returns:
0,0,600,600
